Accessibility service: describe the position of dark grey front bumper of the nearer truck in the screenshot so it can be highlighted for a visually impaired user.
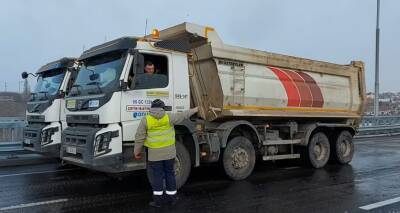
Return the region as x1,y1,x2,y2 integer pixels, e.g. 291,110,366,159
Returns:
60,126,145,173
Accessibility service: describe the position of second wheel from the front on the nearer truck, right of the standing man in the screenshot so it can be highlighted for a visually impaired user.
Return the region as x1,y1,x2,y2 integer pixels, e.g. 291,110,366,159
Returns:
222,136,256,180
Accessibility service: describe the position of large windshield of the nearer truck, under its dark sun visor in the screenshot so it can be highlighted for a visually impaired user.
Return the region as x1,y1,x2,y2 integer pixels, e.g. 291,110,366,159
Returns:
69,52,126,96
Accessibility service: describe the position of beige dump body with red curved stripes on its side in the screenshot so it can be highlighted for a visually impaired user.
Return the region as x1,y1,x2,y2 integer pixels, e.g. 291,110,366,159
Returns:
190,41,365,126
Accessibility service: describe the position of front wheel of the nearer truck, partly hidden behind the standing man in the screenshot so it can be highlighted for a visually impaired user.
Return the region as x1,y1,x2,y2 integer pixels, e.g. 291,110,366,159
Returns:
146,140,192,189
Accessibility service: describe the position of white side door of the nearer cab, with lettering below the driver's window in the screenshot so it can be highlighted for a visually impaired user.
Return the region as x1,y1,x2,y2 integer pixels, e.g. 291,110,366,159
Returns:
121,51,174,141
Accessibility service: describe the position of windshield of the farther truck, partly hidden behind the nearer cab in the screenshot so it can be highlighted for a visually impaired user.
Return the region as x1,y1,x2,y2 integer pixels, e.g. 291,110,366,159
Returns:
31,70,65,101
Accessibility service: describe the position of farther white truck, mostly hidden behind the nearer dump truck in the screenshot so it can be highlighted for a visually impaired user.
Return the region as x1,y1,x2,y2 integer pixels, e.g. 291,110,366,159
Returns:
22,58,76,157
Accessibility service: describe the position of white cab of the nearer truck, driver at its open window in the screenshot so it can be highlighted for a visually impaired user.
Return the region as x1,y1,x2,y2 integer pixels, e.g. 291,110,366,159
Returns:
61,37,190,173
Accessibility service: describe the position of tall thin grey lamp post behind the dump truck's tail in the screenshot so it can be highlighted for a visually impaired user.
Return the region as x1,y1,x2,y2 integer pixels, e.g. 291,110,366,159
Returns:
374,0,380,116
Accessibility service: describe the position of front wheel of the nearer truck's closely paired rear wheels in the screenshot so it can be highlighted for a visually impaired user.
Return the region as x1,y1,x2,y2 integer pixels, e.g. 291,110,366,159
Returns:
307,132,330,168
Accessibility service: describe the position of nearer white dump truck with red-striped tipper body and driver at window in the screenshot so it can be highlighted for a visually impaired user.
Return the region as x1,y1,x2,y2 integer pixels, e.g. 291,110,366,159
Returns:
61,23,365,187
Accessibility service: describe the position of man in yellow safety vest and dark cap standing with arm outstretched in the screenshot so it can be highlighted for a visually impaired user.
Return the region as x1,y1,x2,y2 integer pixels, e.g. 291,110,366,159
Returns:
134,99,198,207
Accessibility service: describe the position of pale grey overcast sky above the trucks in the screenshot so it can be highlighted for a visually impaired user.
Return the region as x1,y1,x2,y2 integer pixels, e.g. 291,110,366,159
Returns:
0,0,400,92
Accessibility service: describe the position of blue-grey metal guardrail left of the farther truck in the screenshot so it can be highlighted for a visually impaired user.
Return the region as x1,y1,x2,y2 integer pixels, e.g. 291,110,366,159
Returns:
0,117,26,151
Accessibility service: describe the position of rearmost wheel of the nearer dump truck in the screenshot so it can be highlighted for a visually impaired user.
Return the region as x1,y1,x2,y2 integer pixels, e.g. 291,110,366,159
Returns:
332,131,354,164
